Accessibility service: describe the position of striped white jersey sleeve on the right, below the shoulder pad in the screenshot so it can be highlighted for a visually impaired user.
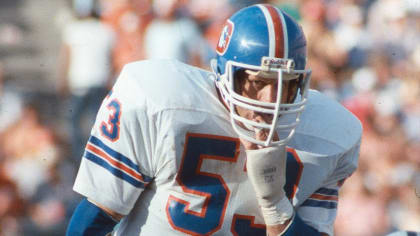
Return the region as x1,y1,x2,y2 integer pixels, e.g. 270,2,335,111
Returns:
297,137,360,236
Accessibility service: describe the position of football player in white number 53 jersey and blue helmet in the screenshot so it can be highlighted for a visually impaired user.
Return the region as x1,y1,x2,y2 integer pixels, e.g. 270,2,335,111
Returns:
67,5,362,236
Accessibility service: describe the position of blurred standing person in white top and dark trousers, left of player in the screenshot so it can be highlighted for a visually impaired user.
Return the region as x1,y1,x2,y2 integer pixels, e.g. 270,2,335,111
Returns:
59,0,115,162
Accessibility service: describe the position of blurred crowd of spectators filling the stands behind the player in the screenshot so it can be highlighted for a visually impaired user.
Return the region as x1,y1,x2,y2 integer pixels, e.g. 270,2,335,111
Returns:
0,0,420,236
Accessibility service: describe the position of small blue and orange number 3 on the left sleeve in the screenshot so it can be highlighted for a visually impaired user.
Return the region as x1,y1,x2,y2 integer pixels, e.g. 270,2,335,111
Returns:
100,99,121,142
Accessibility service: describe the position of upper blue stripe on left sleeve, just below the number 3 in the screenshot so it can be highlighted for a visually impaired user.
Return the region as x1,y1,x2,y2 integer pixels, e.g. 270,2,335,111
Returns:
88,136,152,183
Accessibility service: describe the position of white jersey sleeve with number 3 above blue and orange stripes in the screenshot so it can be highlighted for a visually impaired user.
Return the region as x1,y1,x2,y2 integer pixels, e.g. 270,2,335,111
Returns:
73,65,155,215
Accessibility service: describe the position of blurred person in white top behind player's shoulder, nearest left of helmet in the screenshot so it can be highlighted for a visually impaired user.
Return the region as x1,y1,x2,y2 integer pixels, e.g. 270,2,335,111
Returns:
144,0,206,66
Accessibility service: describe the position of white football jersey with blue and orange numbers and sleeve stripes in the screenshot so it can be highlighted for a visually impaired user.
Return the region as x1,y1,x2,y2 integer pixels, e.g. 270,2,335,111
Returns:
74,60,361,236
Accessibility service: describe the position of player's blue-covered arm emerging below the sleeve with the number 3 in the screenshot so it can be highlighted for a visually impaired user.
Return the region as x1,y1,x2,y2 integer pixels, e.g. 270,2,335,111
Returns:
66,198,123,236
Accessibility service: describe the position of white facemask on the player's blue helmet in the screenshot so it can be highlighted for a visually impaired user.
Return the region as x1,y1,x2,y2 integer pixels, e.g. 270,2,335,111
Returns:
213,57,311,146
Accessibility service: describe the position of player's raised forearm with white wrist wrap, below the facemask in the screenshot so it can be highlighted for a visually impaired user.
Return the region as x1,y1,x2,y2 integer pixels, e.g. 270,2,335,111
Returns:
241,134,323,236
